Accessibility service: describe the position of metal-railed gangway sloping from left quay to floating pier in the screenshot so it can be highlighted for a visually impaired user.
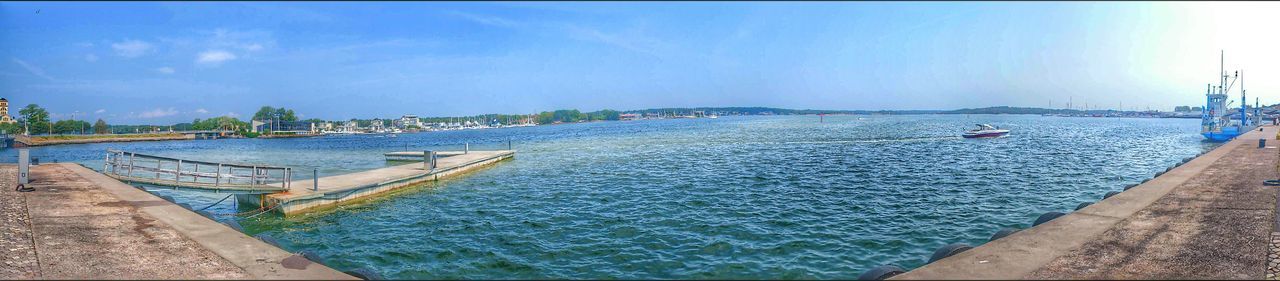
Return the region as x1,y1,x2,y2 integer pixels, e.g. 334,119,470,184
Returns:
102,149,293,190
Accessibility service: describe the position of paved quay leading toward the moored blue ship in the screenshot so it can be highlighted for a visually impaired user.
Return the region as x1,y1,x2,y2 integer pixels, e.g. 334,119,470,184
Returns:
892,126,1280,280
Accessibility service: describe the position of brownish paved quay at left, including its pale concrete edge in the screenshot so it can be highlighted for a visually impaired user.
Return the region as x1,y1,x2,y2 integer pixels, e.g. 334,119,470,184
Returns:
0,163,355,280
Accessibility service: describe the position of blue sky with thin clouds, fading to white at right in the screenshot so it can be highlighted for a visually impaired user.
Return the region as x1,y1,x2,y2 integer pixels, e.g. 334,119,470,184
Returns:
0,3,1280,124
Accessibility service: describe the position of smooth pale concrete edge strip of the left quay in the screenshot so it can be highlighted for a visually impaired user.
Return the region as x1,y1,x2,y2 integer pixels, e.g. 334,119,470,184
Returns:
61,163,356,280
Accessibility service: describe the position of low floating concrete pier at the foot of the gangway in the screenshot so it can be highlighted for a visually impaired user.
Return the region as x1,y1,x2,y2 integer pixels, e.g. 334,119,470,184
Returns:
252,151,516,216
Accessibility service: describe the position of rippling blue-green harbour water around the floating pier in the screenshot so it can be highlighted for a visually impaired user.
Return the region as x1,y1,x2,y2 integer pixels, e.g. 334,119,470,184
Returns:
0,115,1216,278
